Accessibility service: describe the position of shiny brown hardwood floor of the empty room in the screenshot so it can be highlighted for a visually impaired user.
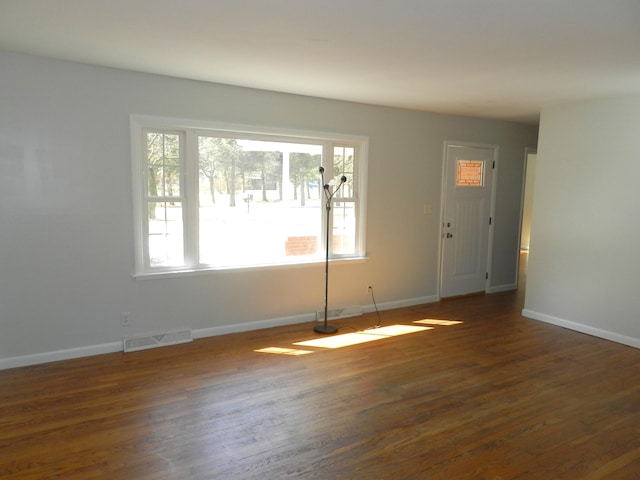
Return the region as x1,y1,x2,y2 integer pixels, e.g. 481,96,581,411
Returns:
0,268,640,480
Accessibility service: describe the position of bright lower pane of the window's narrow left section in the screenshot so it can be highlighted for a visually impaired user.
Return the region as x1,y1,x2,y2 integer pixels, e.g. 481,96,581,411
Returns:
147,202,184,267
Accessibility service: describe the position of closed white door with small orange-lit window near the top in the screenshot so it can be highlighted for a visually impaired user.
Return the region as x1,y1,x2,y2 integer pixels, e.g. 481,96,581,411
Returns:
440,145,497,298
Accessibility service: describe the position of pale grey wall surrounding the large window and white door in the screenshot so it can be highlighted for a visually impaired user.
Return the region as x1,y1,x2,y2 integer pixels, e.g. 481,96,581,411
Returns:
0,53,537,368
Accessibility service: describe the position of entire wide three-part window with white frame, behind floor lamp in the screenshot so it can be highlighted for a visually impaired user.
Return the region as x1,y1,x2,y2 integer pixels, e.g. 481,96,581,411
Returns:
132,117,367,275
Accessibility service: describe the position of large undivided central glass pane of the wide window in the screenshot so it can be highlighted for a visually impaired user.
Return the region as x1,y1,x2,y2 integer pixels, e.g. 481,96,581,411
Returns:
198,136,322,266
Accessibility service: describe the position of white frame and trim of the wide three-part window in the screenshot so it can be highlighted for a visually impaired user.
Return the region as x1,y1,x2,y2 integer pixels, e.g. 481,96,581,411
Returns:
130,115,369,277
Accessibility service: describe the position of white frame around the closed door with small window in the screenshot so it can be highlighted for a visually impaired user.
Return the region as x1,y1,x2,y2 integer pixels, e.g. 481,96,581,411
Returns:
437,140,500,299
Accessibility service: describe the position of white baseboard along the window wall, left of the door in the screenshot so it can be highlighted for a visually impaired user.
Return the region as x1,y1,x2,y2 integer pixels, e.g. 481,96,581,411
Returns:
0,296,439,370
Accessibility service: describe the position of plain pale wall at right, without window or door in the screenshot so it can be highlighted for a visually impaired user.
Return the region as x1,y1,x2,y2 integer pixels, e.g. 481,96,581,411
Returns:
523,96,640,347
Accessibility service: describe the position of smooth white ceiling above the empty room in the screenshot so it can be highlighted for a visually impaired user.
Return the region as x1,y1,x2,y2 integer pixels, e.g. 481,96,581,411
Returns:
0,0,640,124
